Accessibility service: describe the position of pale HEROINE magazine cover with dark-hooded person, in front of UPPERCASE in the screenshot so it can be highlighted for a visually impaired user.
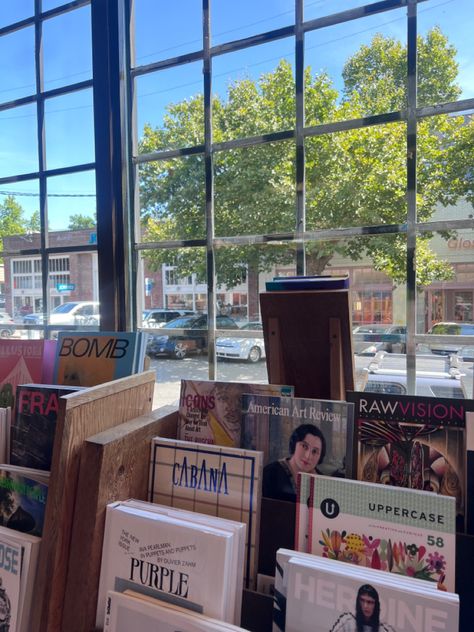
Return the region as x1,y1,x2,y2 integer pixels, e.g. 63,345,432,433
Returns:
286,558,459,632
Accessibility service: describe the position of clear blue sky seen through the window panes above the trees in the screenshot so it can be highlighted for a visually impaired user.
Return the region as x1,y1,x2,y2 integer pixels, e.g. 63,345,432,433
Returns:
0,0,474,230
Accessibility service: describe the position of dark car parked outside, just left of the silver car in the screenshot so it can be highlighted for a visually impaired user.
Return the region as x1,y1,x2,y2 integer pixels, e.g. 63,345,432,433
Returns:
147,314,239,360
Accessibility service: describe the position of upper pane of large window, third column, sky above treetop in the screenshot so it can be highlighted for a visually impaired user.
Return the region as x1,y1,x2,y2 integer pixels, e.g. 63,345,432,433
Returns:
305,9,407,126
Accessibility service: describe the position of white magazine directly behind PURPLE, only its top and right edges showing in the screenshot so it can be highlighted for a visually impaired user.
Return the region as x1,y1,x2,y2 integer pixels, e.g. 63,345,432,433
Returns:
123,499,247,624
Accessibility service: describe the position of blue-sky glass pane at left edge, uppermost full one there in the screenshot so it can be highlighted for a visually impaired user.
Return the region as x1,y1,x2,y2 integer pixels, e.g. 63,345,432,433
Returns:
0,27,36,103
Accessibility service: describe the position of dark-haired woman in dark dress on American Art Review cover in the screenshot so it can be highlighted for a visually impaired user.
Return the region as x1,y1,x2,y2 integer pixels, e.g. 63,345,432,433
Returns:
262,424,326,502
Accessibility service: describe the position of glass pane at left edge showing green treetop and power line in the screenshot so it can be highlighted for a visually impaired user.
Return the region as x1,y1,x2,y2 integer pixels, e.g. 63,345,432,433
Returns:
0,180,39,252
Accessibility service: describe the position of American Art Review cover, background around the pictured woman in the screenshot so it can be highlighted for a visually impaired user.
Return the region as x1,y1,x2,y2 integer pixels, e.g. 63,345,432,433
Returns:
241,394,354,476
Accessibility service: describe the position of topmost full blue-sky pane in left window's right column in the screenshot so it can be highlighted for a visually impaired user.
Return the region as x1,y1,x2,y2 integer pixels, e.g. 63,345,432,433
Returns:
43,6,92,90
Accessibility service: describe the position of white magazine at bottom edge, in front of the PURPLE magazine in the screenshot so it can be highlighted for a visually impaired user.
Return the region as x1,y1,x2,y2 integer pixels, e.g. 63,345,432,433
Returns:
104,591,248,632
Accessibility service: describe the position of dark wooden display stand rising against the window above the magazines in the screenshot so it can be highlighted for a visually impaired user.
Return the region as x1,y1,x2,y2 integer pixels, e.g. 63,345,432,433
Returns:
260,290,354,400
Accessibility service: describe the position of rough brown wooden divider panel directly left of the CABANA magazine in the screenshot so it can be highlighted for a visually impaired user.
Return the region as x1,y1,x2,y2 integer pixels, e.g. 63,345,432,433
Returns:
61,406,178,632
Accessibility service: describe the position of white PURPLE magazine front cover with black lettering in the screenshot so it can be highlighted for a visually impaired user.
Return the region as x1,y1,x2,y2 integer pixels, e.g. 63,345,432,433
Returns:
96,502,235,627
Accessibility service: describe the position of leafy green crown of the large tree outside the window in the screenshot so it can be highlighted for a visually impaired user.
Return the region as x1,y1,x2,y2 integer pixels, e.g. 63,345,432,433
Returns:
140,28,474,287
